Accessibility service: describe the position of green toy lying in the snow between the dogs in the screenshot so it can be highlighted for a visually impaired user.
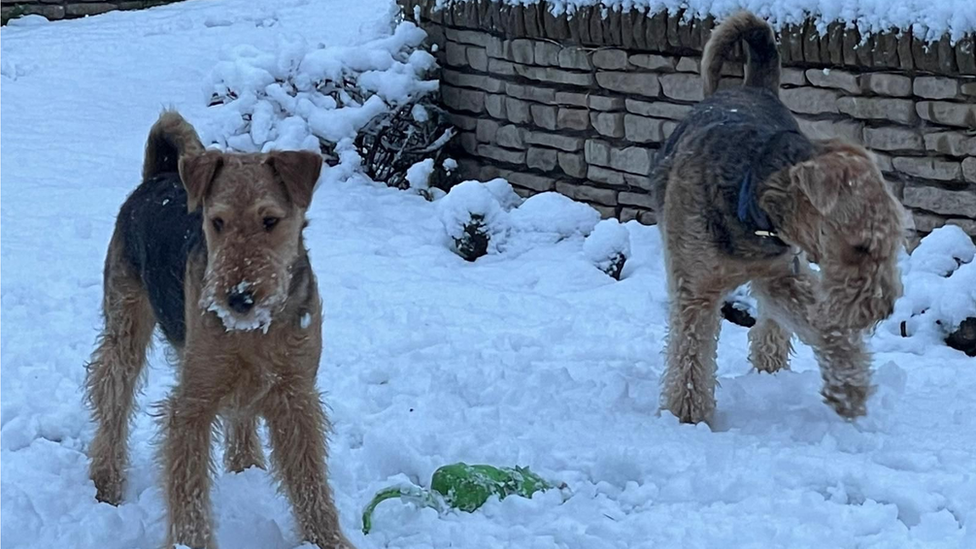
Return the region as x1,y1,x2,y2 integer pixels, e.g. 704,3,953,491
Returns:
363,463,553,534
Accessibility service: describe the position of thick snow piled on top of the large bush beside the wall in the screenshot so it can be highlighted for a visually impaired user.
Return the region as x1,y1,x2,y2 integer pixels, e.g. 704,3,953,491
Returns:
201,22,438,152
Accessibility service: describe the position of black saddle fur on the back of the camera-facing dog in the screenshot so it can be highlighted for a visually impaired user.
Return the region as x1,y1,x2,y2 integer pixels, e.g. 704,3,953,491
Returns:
119,173,206,347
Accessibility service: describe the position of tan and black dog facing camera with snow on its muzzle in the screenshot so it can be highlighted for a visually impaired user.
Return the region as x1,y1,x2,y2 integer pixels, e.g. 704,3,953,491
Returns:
87,112,351,548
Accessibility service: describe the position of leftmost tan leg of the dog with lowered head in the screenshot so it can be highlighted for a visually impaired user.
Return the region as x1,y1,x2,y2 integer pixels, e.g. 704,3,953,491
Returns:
661,277,724,423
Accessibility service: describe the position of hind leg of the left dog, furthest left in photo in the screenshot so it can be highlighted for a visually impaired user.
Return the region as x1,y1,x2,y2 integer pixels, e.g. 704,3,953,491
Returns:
85,232,156,505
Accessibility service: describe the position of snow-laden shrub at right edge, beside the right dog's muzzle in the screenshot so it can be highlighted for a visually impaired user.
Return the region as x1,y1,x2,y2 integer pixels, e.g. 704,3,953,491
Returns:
884,225,976,356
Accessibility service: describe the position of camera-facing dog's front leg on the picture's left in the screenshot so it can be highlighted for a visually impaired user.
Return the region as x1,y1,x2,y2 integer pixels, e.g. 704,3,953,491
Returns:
162,366,219,549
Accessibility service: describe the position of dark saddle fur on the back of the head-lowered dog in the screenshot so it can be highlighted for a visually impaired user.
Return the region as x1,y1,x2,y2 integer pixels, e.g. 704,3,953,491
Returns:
651,88,813,258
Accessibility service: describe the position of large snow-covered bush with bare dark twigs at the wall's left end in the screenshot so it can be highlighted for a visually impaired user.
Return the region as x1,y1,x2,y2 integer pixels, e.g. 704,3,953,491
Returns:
202,22,454,192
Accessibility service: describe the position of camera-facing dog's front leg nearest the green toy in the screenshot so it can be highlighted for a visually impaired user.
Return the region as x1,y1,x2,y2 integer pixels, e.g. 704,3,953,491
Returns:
264,378,353,549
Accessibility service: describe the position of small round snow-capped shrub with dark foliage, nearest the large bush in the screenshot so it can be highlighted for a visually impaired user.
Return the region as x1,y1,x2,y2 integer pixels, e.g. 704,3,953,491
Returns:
436,181,508,261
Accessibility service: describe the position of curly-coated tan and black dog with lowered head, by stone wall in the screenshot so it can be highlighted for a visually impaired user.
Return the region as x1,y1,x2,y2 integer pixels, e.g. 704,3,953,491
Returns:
651,13,903,423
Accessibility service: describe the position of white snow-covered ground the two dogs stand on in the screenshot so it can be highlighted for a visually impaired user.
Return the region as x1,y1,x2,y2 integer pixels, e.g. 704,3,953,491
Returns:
0,0,976,549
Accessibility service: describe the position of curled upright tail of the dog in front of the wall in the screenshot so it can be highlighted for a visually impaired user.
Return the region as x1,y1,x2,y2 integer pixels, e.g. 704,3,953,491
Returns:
702,11,780,97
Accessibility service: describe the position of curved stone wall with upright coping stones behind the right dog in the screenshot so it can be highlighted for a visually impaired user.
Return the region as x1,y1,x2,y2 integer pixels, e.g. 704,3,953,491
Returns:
399,0,976,236
